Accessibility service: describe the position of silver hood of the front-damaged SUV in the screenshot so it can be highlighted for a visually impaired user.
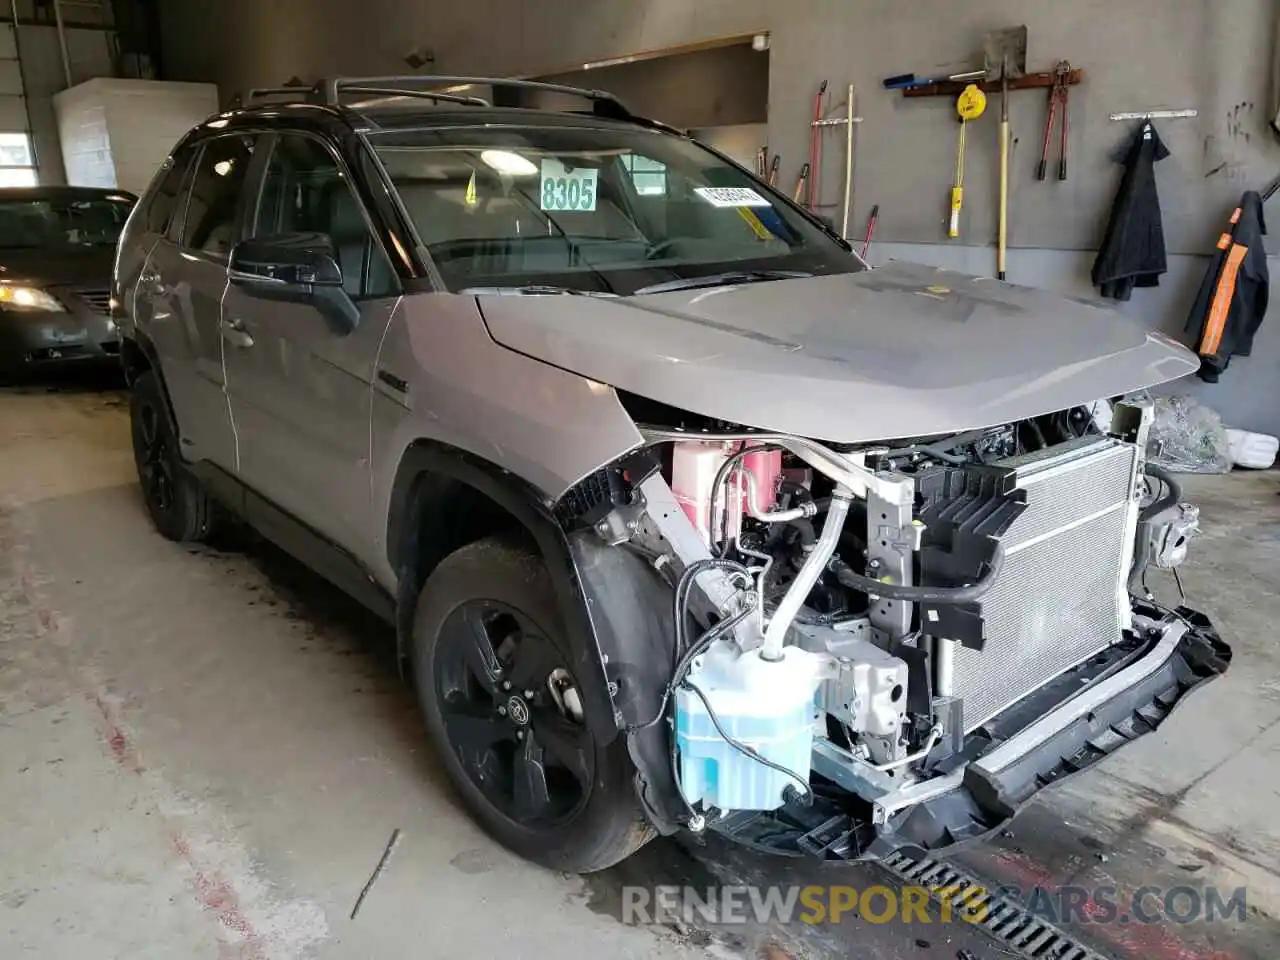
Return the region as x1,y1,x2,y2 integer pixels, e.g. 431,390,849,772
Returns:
480,262,1198,443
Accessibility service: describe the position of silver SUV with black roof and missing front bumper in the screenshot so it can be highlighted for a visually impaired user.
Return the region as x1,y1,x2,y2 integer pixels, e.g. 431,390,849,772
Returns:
113,77,1230,872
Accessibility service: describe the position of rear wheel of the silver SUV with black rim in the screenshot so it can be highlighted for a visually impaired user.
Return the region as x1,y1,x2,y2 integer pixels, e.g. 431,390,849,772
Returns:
129,371,212,543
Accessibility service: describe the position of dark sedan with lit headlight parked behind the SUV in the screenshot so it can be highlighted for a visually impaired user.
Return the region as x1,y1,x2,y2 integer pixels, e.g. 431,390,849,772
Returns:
0,187,137,379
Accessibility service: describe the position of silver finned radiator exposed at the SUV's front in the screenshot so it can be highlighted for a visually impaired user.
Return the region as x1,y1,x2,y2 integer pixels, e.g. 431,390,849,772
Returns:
954,438,1137,730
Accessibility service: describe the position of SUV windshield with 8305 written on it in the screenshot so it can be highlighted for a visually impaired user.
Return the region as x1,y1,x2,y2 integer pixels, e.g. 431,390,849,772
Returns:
370,125,864,296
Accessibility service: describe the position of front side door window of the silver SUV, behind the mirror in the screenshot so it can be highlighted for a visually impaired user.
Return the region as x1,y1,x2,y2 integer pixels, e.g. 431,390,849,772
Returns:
253,134,396,297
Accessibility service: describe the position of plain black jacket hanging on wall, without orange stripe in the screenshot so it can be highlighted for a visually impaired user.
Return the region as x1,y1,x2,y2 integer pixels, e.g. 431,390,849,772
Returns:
1093,120,1169,300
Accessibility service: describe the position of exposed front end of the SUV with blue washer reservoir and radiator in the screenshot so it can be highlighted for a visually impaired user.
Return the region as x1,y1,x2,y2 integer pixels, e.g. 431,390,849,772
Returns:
561,394,1230,859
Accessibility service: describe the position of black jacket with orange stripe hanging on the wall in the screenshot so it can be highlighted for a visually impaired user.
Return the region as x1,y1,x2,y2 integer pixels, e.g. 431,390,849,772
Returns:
1187,189,1271,383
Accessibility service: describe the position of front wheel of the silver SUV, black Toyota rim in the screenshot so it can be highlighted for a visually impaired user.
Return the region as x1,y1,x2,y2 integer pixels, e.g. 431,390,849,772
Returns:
412,540,653,873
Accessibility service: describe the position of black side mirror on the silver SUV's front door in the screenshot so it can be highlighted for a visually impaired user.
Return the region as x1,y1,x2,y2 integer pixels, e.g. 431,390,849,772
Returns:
228,233,360,334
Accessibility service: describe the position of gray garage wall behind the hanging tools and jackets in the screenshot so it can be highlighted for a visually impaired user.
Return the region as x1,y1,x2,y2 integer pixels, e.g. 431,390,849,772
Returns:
154,0,1280,433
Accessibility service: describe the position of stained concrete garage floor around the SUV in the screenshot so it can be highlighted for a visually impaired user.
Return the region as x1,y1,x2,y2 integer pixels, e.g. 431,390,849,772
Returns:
0,376,1280,960
